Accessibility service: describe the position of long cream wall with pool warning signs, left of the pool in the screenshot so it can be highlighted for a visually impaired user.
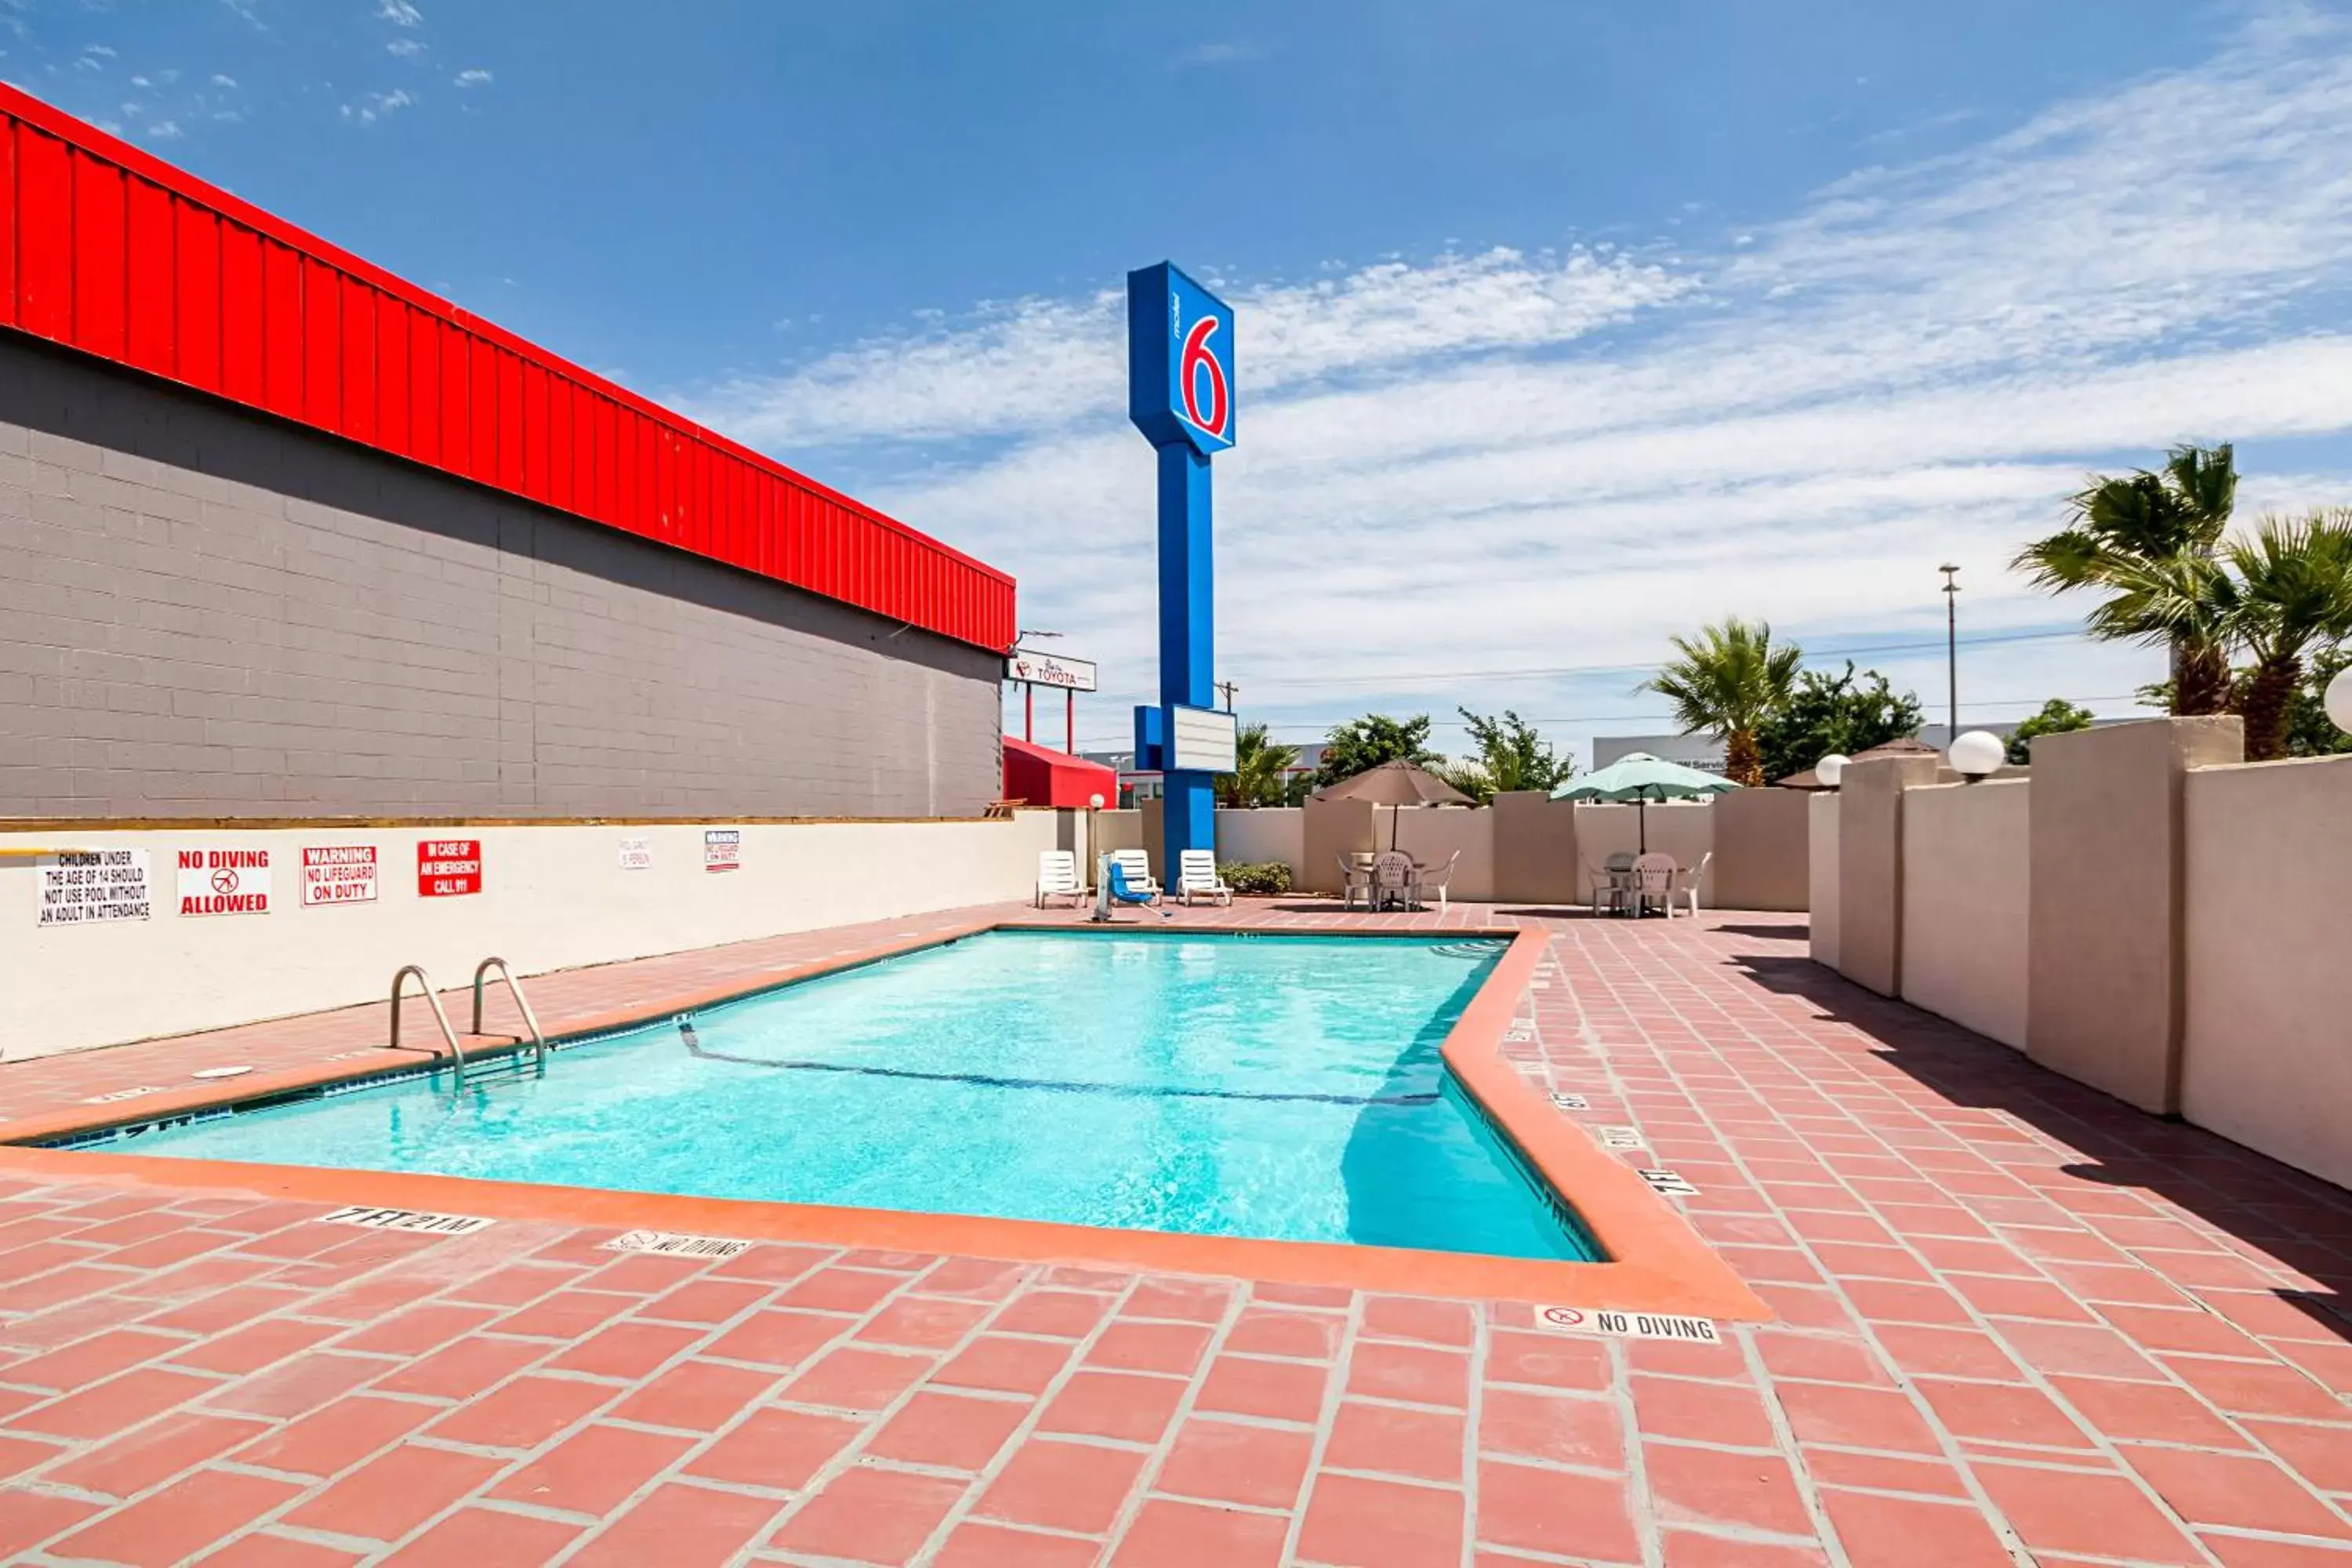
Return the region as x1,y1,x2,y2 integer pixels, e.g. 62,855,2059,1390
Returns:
0,811,1061,1060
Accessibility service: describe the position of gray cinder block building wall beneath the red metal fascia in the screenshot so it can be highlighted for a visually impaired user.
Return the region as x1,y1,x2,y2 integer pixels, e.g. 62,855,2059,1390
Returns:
0,334,1002,818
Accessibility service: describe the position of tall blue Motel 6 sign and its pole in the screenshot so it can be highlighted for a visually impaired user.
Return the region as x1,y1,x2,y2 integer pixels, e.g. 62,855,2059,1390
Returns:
1127,261,1237,881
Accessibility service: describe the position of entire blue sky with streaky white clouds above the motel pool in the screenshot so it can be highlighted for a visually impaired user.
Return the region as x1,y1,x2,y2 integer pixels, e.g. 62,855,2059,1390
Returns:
0,0,2352,761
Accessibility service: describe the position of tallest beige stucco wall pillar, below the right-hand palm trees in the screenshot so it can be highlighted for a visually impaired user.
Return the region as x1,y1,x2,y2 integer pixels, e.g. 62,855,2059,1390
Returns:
2023,717,2244,1114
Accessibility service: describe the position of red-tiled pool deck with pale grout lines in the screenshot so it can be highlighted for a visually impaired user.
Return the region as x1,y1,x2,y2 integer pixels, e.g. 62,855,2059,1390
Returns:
0,905,2352,1568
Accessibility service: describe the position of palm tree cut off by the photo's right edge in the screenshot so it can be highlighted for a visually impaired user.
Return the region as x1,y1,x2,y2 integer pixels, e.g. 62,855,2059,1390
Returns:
2216,508,2352,762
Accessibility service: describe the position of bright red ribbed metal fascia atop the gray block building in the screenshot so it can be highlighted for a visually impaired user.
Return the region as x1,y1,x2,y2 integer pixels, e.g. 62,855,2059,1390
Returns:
0,82,1016,649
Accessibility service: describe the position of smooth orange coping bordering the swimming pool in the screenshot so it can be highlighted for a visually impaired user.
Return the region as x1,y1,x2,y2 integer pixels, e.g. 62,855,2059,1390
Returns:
0,916,1771,1321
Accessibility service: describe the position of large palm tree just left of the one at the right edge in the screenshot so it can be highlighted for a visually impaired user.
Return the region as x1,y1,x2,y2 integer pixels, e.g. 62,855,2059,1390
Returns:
2011,442,2237,715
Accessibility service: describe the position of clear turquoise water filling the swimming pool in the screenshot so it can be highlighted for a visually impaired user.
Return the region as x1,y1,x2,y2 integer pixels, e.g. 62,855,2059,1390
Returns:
118,931,1595,1258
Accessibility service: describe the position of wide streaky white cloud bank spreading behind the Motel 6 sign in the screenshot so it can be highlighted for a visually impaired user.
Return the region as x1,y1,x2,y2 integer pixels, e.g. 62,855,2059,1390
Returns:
673,7,2352,757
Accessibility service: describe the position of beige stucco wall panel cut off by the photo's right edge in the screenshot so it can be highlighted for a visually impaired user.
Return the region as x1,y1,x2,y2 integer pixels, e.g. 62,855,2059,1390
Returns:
2183,757,2352,1187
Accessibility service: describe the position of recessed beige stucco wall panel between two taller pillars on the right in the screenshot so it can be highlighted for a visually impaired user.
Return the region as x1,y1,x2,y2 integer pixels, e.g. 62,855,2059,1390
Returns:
1903,781,2032,1048
